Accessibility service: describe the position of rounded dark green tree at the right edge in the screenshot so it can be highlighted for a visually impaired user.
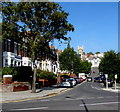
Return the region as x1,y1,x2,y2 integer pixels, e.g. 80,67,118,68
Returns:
99,50,117,77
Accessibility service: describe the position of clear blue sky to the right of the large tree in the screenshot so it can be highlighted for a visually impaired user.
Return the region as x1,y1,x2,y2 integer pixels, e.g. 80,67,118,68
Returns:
55,2,118,53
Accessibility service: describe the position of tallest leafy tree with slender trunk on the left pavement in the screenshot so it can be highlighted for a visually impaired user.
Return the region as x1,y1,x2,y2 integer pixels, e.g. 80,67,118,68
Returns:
3,2,74,92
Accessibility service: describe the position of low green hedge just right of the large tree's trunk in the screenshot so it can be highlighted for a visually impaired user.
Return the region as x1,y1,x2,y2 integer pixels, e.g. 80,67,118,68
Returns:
37,69,56,80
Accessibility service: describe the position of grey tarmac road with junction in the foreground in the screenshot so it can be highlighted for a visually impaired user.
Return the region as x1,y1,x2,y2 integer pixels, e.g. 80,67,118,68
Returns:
2,68,120,112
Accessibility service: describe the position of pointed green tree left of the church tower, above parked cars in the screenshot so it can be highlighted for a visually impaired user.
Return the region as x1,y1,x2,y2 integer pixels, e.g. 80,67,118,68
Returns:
59,45,80,73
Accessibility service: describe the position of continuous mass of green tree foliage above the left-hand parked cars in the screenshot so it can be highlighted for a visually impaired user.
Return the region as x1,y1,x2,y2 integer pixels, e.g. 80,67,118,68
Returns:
59,46,92,74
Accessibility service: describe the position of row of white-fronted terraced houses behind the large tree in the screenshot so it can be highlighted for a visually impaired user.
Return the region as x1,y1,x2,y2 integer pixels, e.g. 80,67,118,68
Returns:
2,39,59,74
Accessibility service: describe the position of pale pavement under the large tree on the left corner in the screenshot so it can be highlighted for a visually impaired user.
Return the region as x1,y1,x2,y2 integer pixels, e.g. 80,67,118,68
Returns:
0,87,67,103
